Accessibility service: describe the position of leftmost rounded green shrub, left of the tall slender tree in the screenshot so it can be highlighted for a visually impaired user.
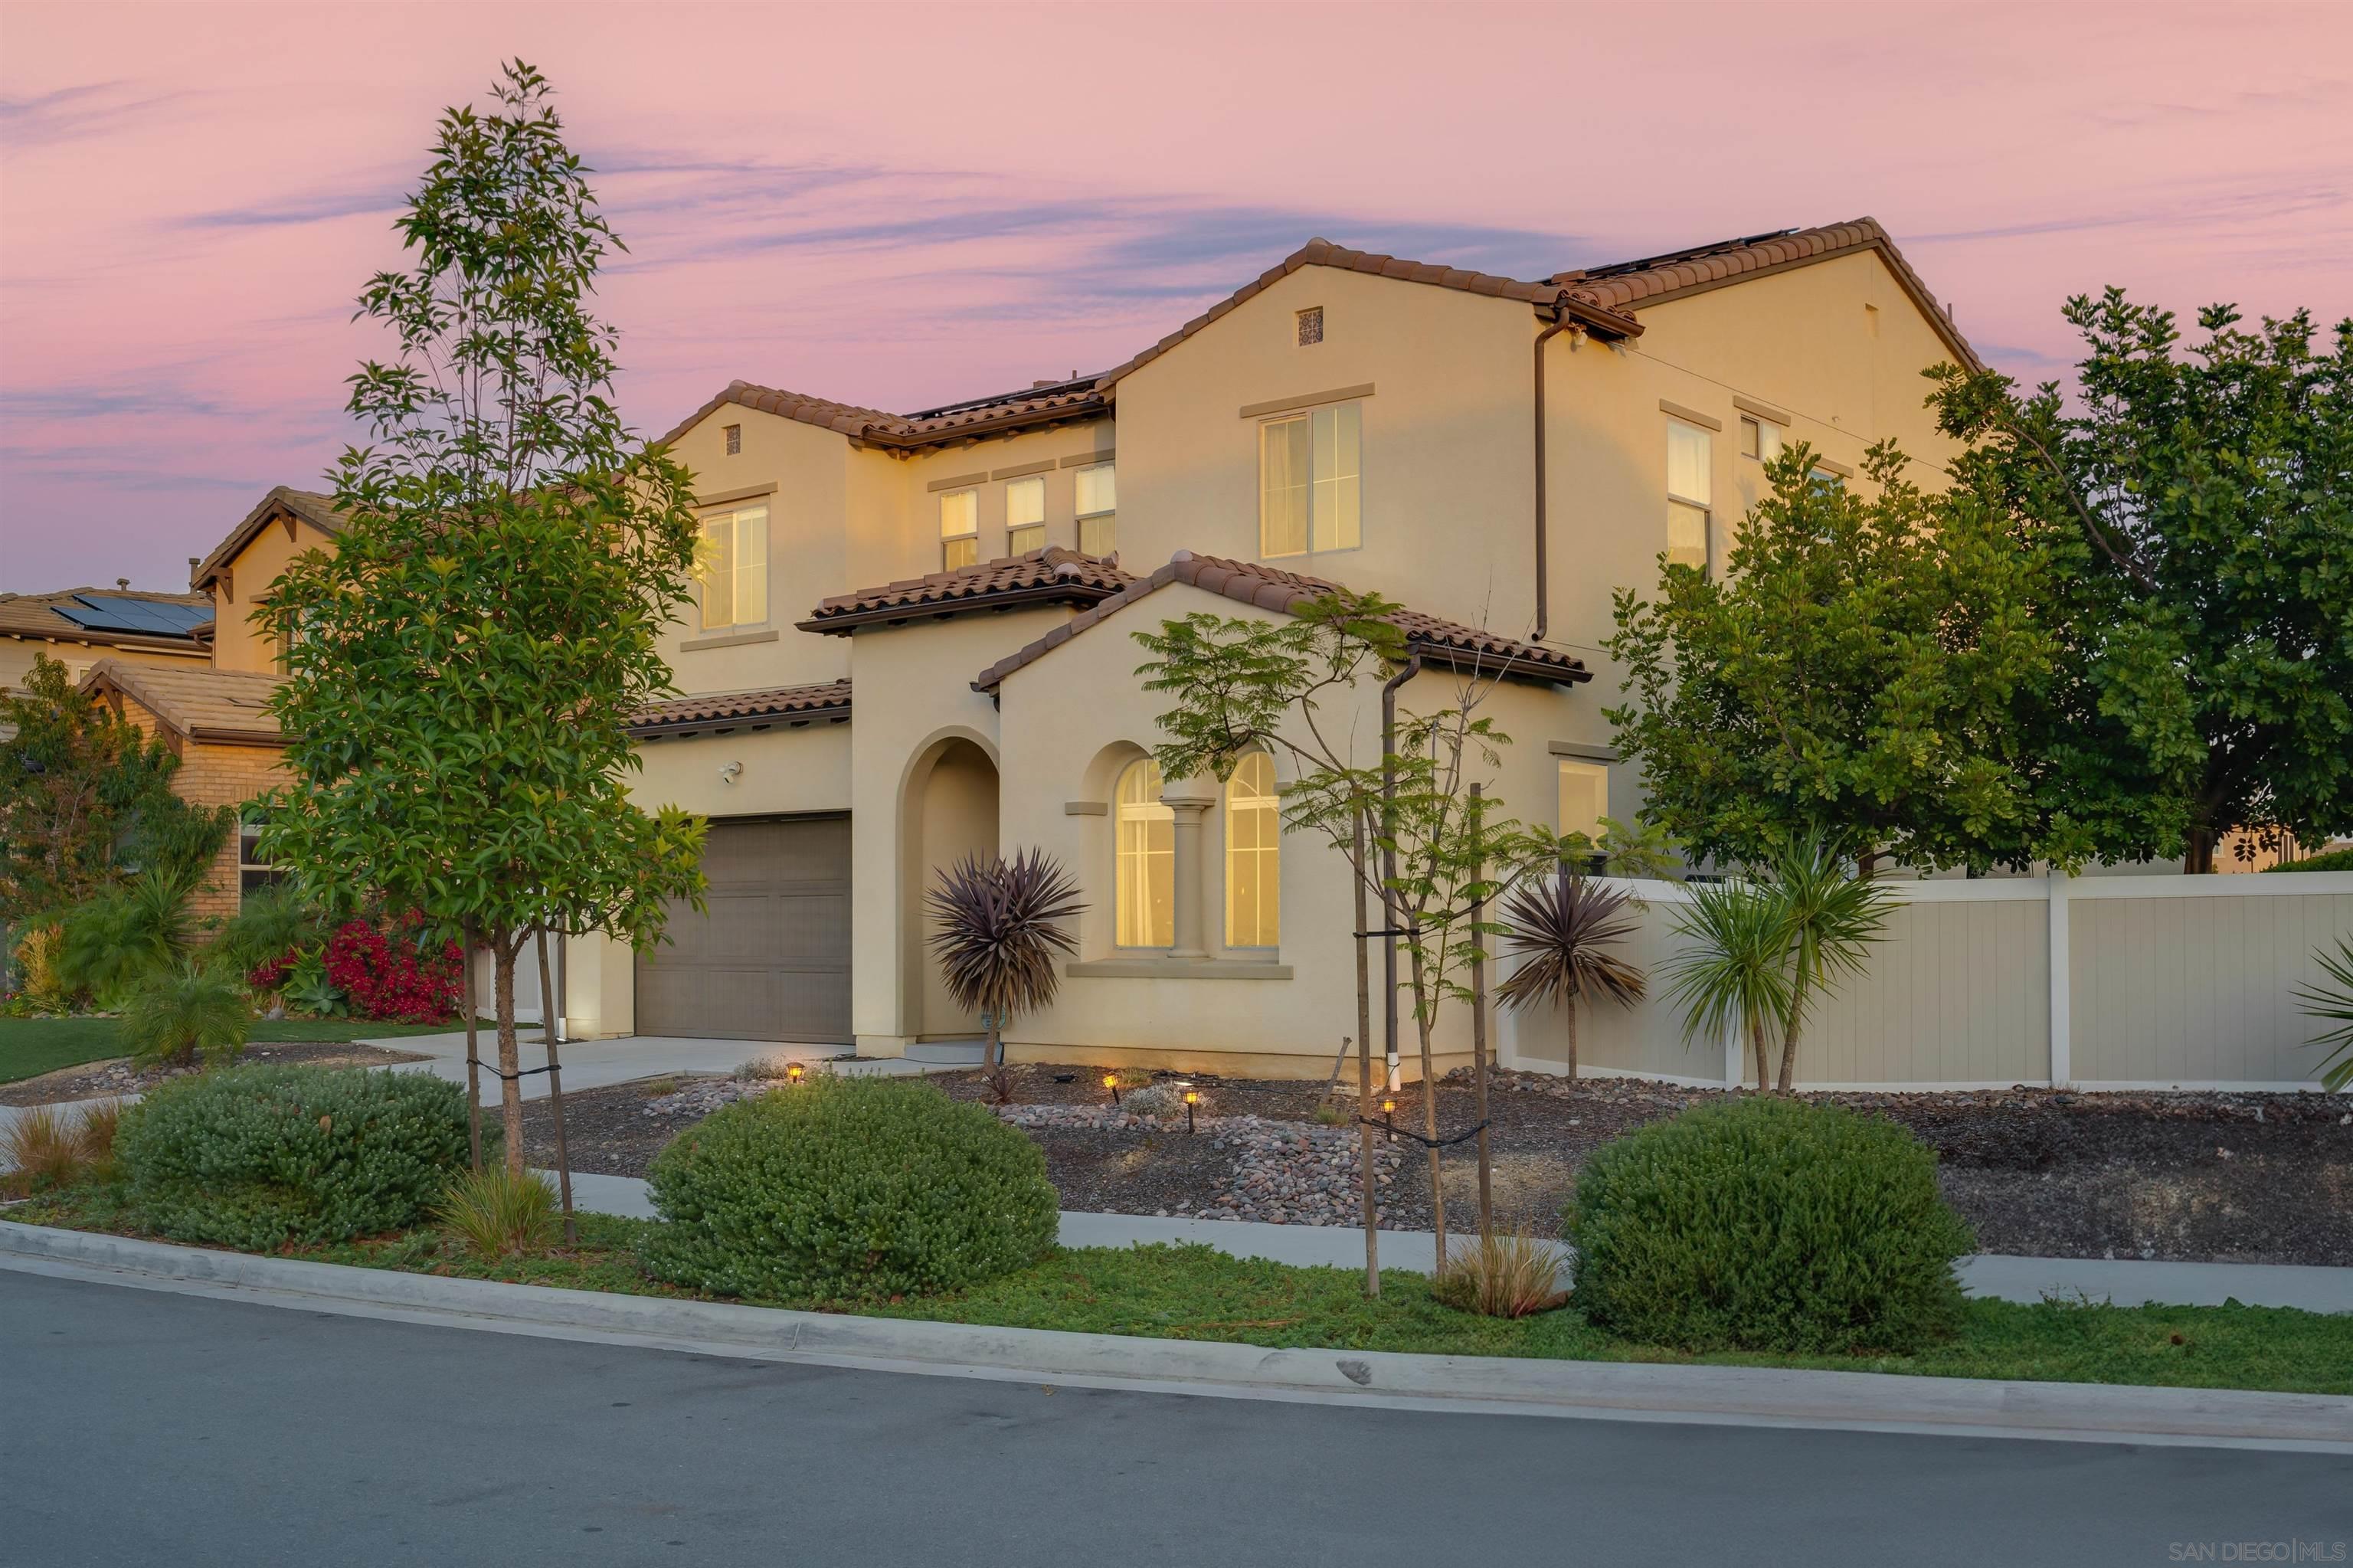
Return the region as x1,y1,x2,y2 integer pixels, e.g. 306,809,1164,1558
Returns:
116,1066,466,1250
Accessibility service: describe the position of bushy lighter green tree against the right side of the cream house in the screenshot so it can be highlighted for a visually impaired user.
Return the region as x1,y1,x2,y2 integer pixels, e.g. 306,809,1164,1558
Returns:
1607,445,2134,871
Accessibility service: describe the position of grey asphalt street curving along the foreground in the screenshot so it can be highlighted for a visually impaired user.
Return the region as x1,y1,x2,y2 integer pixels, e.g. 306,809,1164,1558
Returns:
0,1274,2353,1568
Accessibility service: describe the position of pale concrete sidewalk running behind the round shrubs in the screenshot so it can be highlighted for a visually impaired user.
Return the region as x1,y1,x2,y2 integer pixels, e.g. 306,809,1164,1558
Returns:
545,1175,2353,1311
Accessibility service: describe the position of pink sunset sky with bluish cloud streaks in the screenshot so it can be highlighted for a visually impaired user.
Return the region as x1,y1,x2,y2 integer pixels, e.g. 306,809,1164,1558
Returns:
0,2,2353,588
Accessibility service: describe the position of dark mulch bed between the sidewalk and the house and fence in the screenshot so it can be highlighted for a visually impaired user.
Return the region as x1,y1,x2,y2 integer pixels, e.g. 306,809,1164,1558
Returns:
486,1064,2353,1267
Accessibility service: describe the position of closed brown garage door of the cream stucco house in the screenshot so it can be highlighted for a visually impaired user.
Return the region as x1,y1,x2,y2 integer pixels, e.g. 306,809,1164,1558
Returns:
638,817,849,1046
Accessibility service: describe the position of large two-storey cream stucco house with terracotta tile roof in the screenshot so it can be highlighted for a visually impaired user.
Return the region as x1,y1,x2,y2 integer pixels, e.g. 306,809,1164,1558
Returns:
597,219,1976,1074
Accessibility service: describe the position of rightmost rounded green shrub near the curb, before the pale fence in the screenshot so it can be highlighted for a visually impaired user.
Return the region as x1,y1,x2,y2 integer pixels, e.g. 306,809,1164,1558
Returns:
1563,1097,1974,1354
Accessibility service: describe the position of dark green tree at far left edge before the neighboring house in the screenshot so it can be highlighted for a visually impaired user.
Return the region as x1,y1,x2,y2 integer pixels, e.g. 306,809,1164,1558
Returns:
0,652,235,925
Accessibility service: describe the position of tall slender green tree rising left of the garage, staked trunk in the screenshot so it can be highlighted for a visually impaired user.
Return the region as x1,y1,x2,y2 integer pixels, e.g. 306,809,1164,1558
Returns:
263,61,704,1170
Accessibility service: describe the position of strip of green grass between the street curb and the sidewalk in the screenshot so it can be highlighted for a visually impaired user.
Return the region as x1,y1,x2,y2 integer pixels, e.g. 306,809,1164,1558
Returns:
22,1187,2353,1394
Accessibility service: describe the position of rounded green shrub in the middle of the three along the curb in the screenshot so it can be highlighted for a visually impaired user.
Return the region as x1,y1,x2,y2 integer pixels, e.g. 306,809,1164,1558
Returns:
643,1079,1061,1302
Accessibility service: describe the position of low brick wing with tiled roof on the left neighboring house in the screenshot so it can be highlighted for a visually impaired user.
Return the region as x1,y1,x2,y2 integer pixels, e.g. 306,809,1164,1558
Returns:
83,660,285,916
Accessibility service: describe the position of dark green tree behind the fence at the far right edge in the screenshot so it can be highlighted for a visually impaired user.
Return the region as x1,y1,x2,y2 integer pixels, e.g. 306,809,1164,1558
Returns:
1929,287,2353,871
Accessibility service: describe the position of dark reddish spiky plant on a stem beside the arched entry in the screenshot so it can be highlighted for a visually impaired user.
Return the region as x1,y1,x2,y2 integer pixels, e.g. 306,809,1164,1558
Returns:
925,850,1087,1105
